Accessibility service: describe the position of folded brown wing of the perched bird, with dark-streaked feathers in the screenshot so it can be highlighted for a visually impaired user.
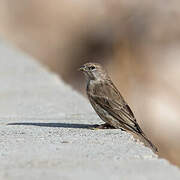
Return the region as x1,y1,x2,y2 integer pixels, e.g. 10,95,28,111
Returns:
90,82,143,133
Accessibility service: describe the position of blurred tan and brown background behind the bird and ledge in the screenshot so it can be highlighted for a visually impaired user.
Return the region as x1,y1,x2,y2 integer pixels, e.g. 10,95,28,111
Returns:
0,0,180,166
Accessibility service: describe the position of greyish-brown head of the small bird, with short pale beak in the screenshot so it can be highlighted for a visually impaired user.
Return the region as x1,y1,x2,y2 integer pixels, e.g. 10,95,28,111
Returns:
79,63,109,80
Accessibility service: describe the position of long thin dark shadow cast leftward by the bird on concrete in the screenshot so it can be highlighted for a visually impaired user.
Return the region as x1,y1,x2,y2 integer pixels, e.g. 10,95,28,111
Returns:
7,122,96,129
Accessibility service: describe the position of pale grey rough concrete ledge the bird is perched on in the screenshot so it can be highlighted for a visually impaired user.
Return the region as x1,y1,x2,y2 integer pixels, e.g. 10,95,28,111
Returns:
0,43,180,180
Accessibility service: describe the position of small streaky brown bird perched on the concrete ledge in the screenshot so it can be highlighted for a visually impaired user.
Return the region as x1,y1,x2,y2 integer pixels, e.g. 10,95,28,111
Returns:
79,63,157,152
